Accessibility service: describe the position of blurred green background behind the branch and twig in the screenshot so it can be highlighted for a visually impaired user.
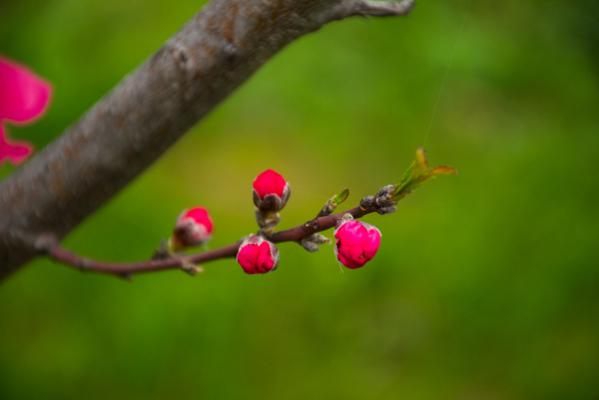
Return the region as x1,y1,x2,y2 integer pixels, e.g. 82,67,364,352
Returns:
0,0,599,399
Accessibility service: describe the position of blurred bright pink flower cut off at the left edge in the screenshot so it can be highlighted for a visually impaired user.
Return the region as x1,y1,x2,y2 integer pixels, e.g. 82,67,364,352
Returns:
0,57,52,165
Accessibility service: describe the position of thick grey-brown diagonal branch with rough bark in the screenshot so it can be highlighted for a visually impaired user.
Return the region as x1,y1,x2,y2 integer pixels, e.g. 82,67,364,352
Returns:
0,0,409,279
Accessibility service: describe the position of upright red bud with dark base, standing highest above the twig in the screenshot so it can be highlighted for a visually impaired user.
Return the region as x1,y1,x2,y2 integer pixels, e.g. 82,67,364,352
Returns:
252,169,290,211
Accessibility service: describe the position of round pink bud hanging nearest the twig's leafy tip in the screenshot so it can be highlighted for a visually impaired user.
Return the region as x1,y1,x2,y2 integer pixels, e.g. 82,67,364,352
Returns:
335,219,381,269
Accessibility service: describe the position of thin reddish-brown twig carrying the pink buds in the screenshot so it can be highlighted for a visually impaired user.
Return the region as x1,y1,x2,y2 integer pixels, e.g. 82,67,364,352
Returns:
38,207,376,277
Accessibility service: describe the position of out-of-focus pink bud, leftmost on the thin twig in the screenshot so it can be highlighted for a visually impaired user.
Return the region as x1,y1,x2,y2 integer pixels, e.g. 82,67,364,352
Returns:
172,207,214,249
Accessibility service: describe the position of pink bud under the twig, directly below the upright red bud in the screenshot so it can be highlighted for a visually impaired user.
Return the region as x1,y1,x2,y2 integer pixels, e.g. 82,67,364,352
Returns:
237,235,279,274
